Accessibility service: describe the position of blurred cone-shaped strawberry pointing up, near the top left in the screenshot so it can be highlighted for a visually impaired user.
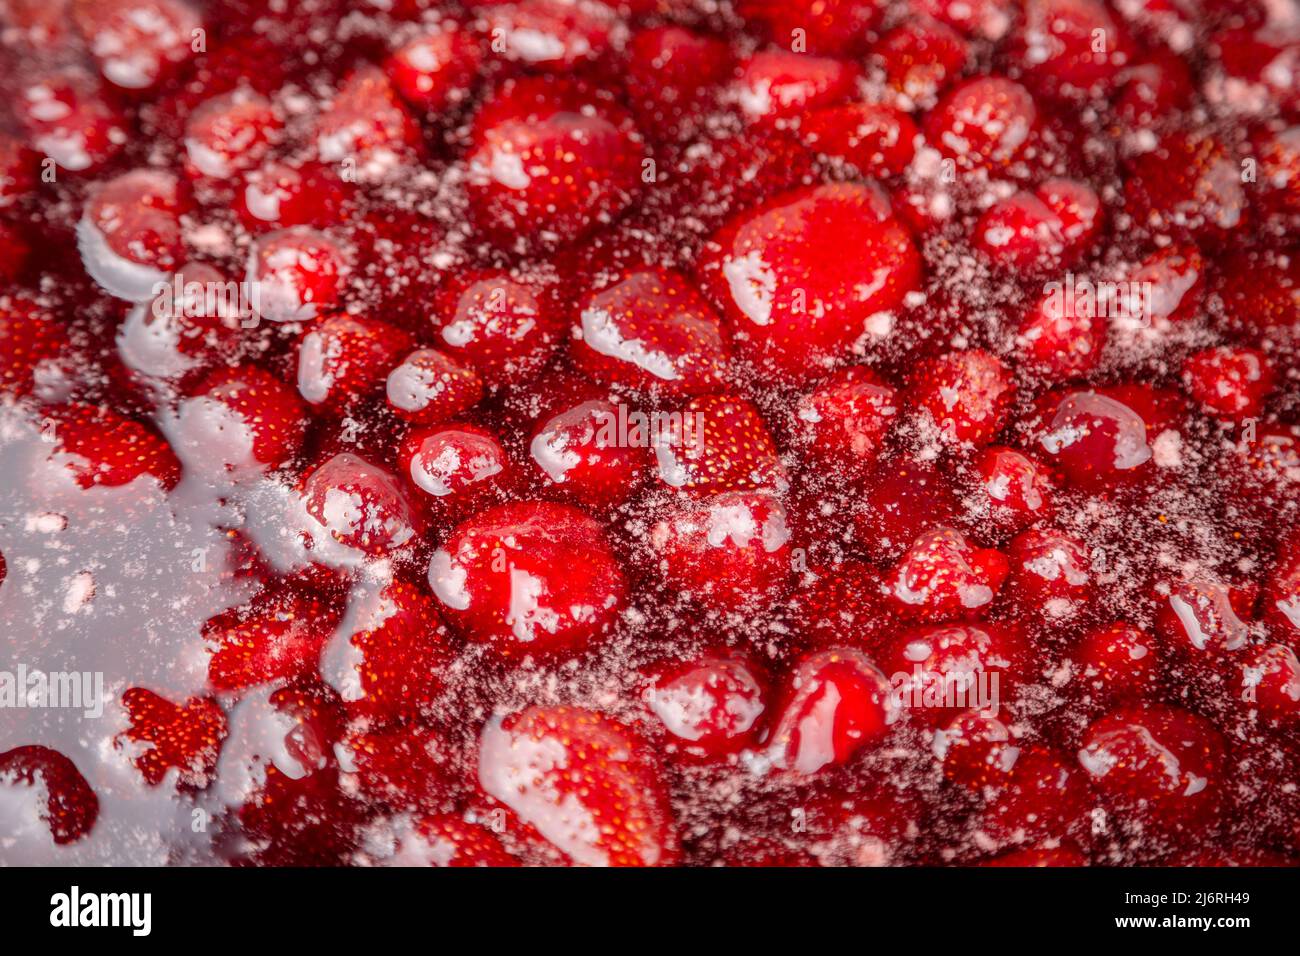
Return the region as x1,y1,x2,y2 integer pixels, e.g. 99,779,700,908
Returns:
313,66,420,182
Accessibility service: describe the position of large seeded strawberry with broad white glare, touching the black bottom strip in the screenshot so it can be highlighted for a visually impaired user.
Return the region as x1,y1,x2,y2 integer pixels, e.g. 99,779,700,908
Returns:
478,706,679,866
